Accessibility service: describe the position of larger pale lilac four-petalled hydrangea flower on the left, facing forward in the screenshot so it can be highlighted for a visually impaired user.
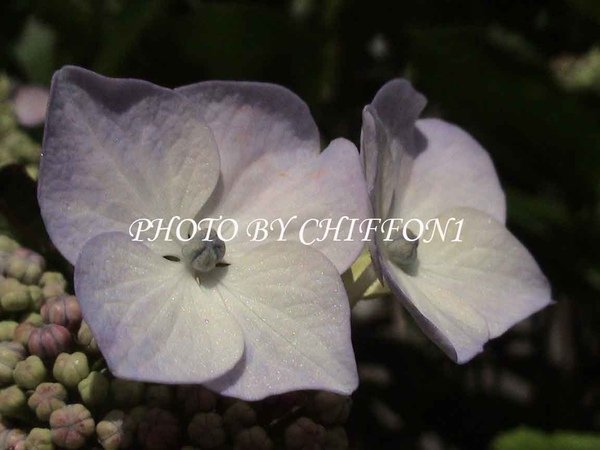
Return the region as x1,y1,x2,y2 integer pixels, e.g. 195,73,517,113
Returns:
38,67,370,399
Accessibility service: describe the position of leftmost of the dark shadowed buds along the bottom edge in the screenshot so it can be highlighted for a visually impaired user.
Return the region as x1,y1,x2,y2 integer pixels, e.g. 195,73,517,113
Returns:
138,408,181,450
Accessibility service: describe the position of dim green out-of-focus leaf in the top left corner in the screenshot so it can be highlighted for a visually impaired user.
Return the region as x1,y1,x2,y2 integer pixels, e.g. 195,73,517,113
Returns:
14,17,56,84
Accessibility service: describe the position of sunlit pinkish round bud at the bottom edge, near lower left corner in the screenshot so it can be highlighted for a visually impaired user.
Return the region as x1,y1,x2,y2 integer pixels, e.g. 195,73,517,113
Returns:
50,404,96,449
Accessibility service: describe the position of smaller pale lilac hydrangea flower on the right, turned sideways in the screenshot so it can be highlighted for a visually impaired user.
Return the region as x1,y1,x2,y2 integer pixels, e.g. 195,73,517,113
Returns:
361,80,551,363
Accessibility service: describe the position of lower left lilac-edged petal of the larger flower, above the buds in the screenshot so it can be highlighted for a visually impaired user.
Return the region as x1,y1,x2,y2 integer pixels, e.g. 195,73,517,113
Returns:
75,232,244,383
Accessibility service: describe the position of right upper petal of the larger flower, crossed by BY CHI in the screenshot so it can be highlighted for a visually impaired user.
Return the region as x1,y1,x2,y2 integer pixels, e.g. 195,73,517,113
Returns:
213,139,370,273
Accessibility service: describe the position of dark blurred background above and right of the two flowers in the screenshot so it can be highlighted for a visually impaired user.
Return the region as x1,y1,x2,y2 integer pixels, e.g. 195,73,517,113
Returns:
0,0,600,450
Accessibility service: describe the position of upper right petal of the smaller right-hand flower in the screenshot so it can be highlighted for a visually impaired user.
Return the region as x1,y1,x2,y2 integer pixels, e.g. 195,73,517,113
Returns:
393,119,506,223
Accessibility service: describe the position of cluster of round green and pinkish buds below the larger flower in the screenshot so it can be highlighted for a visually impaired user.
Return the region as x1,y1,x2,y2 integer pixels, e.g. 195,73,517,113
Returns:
0,236,351,450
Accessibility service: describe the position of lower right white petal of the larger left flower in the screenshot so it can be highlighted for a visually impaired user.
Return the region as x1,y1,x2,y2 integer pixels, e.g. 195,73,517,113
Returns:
208,242,358,400
